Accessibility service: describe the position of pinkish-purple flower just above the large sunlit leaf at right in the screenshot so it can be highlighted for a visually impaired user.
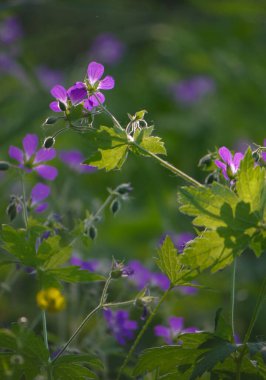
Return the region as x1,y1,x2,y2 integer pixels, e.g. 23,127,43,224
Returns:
214,146,244,180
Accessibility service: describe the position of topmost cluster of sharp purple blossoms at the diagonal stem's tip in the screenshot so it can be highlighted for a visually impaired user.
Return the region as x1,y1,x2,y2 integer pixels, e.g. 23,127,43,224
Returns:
50,62,115,112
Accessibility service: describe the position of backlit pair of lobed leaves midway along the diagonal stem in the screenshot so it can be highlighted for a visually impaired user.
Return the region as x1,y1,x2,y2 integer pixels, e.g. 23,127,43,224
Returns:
83,126,166,171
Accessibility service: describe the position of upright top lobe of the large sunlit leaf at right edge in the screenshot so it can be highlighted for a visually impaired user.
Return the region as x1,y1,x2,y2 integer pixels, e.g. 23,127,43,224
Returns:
236,148,266,215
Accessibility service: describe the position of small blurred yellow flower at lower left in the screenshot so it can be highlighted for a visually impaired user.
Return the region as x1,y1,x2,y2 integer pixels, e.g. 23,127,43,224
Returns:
36,288,66,312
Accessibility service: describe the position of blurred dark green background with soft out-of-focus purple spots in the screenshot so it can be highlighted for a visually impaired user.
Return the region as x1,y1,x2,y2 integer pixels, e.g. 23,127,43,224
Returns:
0,0,266,374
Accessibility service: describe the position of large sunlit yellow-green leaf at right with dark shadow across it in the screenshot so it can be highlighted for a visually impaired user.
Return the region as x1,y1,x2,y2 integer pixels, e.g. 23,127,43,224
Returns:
178,150,266,272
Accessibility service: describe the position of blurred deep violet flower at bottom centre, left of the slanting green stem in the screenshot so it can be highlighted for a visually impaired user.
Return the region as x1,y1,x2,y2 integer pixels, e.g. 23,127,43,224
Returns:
103,309,138,345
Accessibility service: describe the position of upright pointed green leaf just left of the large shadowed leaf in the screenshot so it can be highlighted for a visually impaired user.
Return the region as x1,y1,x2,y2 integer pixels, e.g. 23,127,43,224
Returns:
155,236,191,285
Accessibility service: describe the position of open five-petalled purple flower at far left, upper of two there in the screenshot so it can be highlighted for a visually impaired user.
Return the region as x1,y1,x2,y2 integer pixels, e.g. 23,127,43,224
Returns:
8,134,57,181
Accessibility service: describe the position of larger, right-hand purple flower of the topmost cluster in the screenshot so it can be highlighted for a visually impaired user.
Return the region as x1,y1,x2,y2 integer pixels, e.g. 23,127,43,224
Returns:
67,62,115,111
